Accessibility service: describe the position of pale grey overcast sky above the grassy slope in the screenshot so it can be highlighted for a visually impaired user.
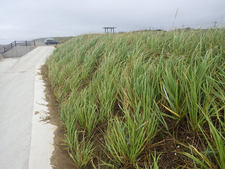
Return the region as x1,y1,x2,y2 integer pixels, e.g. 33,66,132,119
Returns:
0,0,225,43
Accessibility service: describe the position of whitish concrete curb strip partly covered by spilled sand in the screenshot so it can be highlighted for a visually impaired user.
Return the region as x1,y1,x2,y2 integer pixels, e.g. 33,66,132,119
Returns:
29,65,57,169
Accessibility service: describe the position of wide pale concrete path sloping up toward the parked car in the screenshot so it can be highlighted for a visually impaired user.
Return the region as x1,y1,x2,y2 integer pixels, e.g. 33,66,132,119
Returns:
0,46,54,169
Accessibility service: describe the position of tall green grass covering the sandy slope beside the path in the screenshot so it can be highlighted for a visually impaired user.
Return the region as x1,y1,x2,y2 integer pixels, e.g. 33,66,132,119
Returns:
46,29,225,169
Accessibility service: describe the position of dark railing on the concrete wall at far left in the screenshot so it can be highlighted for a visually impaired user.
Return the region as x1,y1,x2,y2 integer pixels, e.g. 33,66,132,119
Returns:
0,41,36,54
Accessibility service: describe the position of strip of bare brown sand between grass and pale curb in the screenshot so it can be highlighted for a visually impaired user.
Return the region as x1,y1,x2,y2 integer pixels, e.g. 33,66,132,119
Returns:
41,65,75,169
